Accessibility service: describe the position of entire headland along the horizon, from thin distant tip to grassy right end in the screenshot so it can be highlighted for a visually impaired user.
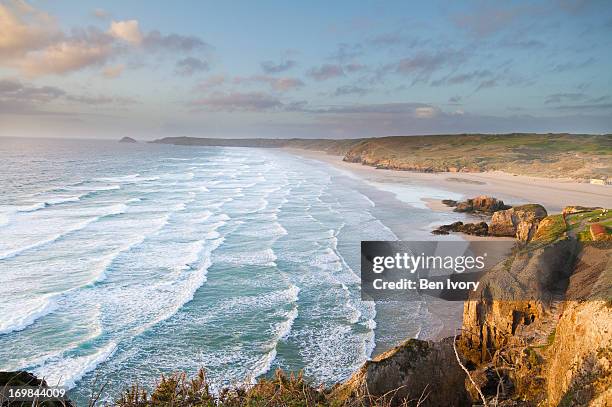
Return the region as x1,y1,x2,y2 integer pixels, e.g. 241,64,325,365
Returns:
153,133,612,184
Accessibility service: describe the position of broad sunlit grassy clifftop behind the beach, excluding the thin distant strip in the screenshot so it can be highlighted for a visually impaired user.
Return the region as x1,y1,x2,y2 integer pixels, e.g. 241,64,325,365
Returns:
344,134,612,178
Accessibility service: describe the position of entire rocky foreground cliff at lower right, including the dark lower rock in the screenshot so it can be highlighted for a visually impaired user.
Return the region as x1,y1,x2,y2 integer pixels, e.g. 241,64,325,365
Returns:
342,205,612,406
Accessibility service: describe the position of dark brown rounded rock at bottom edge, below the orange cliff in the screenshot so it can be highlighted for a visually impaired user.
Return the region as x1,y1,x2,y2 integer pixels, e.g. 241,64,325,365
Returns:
333,338,468,406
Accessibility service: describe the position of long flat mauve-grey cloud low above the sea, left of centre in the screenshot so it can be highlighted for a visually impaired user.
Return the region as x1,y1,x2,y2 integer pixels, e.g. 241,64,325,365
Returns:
189,92,284,112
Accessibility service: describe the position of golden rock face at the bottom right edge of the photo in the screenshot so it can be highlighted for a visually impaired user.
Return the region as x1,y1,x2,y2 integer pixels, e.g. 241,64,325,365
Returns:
545,244,612,406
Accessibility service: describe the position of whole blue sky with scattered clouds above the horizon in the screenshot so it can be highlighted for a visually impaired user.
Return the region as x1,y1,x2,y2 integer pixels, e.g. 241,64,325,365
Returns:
0,0,612,140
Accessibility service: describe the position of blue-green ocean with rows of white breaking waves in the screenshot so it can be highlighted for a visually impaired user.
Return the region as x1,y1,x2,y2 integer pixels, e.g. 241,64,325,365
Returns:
0,138,457,402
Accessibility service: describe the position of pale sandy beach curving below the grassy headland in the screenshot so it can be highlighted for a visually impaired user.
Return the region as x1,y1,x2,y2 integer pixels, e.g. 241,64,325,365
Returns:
286,149,612,213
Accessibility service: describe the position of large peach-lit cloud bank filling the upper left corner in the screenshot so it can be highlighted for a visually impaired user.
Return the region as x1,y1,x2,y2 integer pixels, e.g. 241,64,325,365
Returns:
0,1,211,77
